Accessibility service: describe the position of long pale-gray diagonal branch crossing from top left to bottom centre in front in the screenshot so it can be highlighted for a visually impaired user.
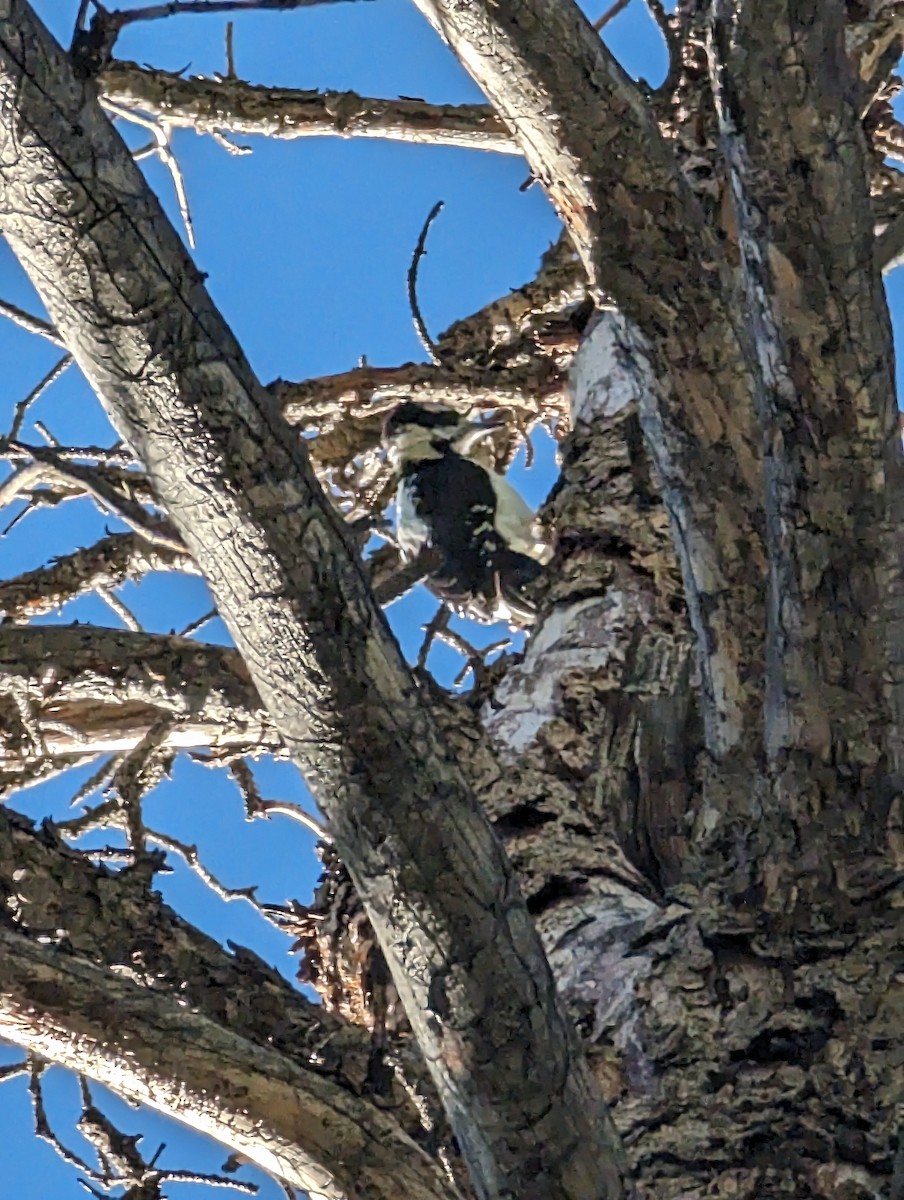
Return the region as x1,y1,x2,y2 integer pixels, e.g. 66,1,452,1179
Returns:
0,0,622,1200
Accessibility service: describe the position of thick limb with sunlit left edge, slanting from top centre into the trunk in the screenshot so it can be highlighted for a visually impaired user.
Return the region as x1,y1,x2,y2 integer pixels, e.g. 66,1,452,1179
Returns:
417,0,764,758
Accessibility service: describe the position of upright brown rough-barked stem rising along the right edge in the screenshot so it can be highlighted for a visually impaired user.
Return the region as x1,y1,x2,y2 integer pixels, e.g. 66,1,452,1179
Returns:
711,2,903,907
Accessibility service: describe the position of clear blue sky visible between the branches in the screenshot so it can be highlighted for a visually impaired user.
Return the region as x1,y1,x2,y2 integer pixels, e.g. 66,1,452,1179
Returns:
0,0,899,1200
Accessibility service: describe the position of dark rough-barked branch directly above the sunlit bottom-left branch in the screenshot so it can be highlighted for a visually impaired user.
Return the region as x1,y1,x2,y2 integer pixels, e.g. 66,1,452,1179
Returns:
0,808,461,1185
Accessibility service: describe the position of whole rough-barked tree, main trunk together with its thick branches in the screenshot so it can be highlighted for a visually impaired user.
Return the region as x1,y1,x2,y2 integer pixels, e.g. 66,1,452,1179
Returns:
0,0,904,1200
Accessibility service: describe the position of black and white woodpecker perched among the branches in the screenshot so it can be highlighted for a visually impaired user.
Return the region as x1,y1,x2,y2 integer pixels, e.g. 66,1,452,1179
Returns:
383,401,549,625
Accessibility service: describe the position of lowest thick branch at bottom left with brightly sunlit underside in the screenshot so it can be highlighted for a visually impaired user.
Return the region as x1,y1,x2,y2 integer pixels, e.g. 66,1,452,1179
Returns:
0,930,450,1200
